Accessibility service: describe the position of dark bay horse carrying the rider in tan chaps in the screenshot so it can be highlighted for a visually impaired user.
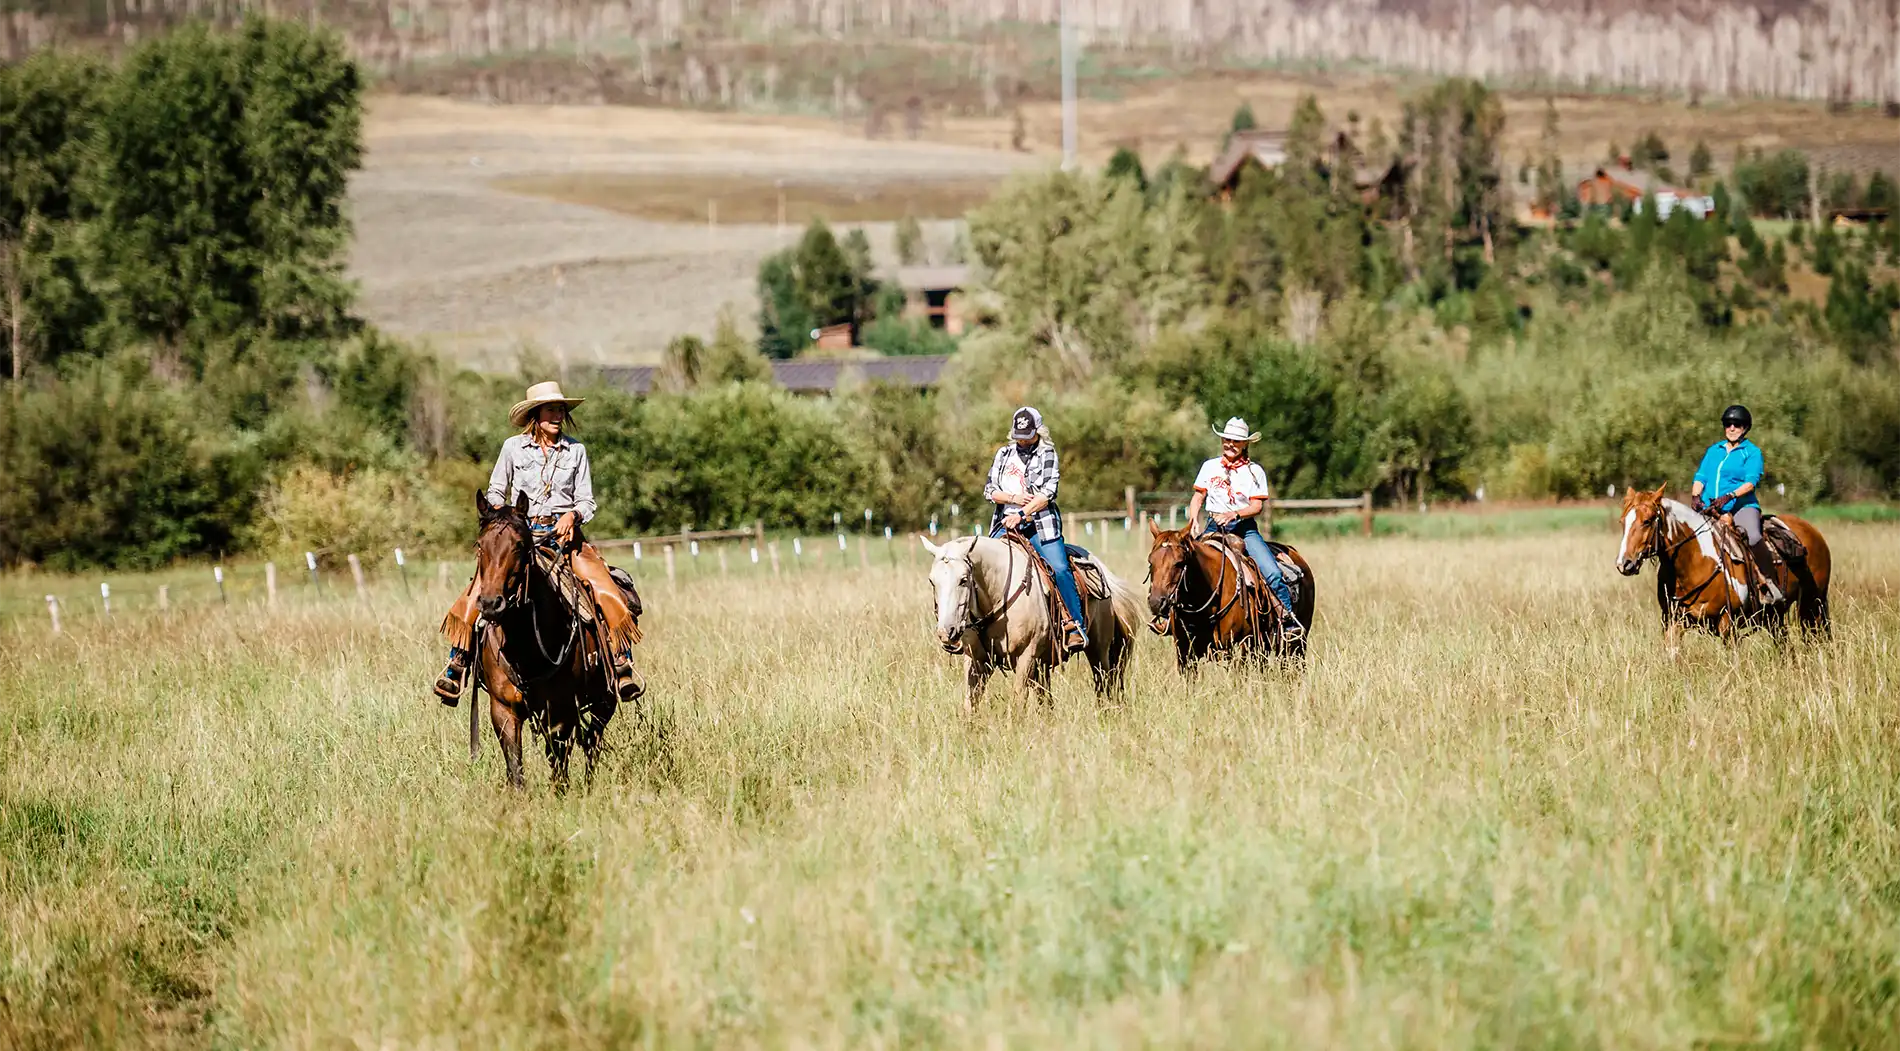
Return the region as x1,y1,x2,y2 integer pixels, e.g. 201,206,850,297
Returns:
469,490,638,789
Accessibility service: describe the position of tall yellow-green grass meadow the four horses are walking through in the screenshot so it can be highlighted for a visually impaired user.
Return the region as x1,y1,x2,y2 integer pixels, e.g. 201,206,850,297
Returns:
0,519,1900,1049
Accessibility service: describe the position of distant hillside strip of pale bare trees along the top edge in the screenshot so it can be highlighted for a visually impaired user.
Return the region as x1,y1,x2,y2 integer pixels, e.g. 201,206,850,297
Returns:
0,0,1900,108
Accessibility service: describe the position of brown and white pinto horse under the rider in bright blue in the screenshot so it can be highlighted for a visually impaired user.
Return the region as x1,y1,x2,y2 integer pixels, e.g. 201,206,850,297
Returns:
1617,485,1834,650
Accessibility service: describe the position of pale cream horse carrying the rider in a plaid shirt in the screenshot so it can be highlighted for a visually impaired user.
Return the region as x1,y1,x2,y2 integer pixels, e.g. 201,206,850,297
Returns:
918,536,1142,713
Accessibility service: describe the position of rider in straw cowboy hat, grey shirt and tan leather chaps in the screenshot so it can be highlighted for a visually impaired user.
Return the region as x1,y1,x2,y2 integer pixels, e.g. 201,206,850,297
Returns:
435,380,637,705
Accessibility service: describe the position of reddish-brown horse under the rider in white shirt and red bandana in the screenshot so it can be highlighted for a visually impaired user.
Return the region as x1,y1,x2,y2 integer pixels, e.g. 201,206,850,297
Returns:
1148,523,1315,671
